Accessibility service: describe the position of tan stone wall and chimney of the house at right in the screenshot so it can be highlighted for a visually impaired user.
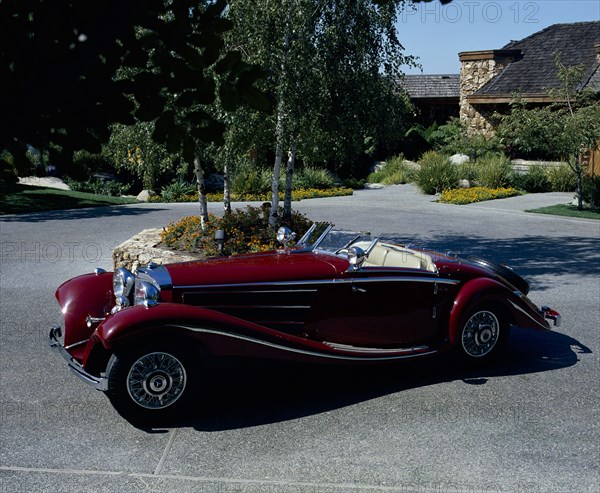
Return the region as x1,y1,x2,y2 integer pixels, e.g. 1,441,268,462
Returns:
459,50,513,137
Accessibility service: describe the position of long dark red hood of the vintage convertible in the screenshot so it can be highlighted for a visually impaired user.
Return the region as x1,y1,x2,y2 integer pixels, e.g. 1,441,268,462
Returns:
165,252,348,288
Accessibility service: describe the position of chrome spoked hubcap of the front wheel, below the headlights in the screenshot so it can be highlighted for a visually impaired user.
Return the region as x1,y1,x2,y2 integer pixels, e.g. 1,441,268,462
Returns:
127,352,187,409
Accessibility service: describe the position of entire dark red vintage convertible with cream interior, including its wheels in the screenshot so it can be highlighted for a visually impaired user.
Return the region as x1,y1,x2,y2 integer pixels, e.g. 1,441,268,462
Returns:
50,224,560,420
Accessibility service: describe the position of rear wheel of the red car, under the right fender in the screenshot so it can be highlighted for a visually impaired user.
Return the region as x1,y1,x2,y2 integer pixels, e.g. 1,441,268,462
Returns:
458,305,509,362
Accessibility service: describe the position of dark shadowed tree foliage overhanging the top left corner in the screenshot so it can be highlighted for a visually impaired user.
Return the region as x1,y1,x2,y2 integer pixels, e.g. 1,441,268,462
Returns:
0,0,265,185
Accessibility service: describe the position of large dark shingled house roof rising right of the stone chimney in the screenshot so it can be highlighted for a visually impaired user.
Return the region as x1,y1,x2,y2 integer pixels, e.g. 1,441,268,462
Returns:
474,21,600,97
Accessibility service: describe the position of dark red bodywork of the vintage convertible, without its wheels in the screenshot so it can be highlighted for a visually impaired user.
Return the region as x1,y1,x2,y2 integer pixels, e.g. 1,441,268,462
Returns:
50,229,560,420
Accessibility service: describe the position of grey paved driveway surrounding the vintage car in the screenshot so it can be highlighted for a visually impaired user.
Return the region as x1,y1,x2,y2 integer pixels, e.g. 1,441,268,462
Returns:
0,186,600,493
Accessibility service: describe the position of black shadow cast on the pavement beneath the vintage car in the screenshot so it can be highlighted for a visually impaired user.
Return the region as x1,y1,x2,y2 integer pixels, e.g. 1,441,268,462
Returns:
135,329,592,432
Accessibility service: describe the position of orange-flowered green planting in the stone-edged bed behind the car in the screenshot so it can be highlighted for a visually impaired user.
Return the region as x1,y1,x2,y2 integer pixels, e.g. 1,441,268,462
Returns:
161,206,312,257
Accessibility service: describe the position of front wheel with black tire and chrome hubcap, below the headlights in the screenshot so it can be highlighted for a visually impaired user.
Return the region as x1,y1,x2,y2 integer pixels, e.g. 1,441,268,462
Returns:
107,344,194,423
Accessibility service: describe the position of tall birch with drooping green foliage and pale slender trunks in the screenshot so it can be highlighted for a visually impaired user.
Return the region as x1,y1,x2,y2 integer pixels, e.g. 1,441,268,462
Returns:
228,0,422,225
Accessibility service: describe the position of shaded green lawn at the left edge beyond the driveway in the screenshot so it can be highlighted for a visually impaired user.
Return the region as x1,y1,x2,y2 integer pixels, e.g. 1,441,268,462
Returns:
0,185,137,214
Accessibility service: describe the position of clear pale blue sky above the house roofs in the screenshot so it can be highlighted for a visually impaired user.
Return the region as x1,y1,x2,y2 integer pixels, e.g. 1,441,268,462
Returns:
397,0,600,74
